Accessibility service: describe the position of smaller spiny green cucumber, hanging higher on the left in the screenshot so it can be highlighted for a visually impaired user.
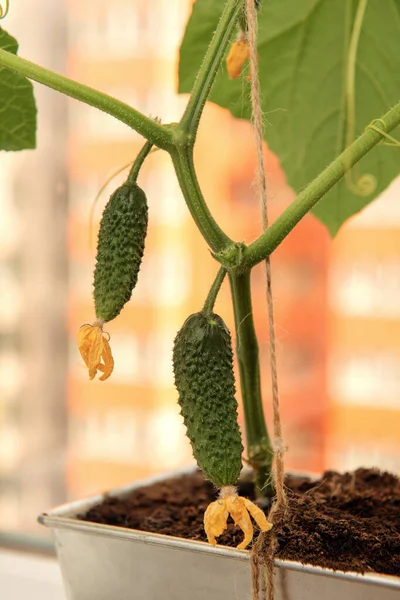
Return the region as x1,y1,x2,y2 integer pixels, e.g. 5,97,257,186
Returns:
93,183,148,322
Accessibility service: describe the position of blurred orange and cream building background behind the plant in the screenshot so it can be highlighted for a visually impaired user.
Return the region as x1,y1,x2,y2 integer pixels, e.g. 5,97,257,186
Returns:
0,0,400,534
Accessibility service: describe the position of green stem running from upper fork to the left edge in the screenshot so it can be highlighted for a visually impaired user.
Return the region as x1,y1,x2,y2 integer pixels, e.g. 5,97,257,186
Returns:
0,50,172,149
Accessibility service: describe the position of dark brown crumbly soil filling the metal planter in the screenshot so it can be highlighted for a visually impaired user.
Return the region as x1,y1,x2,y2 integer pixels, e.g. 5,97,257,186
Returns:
81,469,400,576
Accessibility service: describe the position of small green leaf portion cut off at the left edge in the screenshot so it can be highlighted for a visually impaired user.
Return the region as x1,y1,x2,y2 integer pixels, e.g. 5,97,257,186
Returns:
0,28,36,150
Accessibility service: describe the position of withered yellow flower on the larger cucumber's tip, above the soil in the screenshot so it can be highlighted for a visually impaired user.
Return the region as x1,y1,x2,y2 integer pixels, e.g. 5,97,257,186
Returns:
204,486,272,550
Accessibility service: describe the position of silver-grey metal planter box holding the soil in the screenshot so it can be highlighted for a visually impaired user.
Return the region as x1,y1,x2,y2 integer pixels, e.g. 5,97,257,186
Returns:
39,469,400,600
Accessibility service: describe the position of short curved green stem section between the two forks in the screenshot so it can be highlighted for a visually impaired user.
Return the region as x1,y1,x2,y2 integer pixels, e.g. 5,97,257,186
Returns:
170,146,233,252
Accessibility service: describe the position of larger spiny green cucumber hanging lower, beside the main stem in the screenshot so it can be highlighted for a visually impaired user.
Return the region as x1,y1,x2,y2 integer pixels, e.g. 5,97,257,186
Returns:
173,312,243,487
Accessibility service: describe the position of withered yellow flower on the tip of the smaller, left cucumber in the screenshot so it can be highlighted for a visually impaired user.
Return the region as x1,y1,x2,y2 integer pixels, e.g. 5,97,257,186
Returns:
78,322,114,381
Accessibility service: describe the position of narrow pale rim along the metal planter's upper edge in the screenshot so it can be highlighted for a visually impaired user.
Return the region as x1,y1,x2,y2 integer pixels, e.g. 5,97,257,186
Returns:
38,466,400,590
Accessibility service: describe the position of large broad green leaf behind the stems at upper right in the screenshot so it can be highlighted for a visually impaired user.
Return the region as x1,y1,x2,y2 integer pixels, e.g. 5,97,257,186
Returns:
179,0,400,235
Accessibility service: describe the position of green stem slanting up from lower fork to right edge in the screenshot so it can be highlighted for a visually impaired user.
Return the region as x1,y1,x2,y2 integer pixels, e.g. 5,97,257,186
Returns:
242,102,400,269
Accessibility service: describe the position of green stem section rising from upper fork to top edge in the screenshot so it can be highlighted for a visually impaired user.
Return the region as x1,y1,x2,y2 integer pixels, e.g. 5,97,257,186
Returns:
179,0,243,136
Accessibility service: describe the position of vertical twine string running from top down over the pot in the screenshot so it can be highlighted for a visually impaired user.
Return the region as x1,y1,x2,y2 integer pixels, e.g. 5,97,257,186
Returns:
246,0,287,600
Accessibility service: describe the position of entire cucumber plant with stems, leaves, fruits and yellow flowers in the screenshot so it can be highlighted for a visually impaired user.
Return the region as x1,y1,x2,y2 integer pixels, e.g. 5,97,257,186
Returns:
0,0,400,547
